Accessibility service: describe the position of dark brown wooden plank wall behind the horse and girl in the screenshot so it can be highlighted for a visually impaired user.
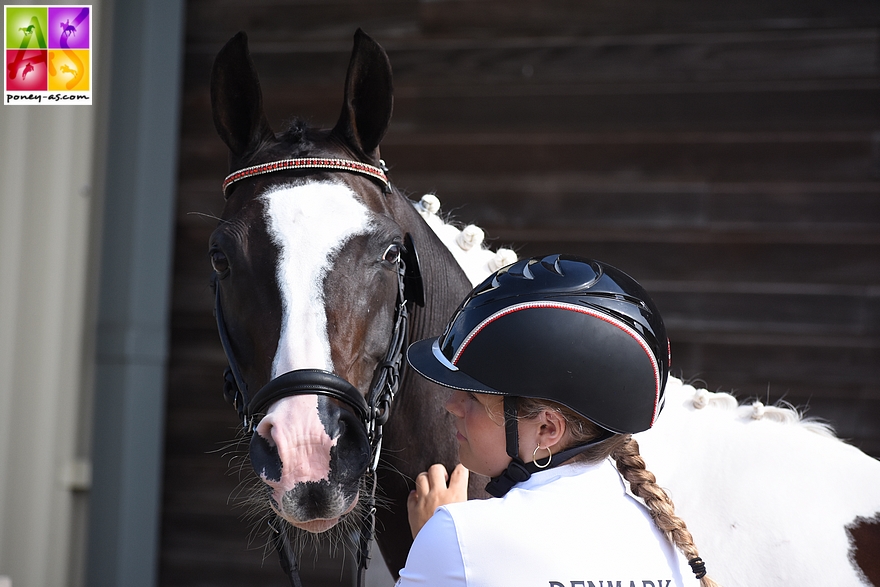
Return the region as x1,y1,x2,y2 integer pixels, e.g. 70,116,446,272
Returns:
160,0,880,587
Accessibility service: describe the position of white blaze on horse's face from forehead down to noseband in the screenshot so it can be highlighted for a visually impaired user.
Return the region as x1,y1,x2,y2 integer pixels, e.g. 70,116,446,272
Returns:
260,181,373,377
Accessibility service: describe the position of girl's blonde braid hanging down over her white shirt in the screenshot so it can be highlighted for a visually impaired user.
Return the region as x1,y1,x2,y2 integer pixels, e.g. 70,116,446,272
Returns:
611,437,719,587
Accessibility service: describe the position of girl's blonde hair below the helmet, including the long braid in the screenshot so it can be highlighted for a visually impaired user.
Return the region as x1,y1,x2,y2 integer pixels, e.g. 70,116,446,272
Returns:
517,397,719,587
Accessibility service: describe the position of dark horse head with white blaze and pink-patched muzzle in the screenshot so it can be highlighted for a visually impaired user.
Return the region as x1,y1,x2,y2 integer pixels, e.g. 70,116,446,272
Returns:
210,31,470,552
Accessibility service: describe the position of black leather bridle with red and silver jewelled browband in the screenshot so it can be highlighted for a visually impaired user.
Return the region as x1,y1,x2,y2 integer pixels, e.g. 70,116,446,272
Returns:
212,157,424,587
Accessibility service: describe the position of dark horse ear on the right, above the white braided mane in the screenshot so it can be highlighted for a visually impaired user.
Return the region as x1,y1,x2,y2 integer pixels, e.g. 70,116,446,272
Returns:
333,29,394,162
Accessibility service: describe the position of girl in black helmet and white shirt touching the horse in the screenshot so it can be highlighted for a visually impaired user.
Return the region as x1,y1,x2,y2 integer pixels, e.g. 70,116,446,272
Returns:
398,255,715,587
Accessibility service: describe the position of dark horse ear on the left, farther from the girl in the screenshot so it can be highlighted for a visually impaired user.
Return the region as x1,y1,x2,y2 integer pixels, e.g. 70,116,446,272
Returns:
211,32,275,157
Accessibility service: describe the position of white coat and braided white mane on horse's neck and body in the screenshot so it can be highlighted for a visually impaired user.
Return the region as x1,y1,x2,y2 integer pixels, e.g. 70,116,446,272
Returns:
415,195,880,587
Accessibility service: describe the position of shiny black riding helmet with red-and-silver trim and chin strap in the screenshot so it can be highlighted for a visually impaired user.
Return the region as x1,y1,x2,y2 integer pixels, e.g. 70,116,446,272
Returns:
407,255,669,495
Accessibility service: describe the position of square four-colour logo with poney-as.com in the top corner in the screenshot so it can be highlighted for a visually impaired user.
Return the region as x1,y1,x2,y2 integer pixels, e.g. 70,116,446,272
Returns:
3,5,92,105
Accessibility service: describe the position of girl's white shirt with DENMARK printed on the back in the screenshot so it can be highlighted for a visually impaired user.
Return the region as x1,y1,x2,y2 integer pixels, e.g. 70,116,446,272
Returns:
397,460,699,587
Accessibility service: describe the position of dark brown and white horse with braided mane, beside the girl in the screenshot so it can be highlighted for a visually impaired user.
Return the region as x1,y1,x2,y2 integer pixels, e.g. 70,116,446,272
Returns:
210,31,880,587
